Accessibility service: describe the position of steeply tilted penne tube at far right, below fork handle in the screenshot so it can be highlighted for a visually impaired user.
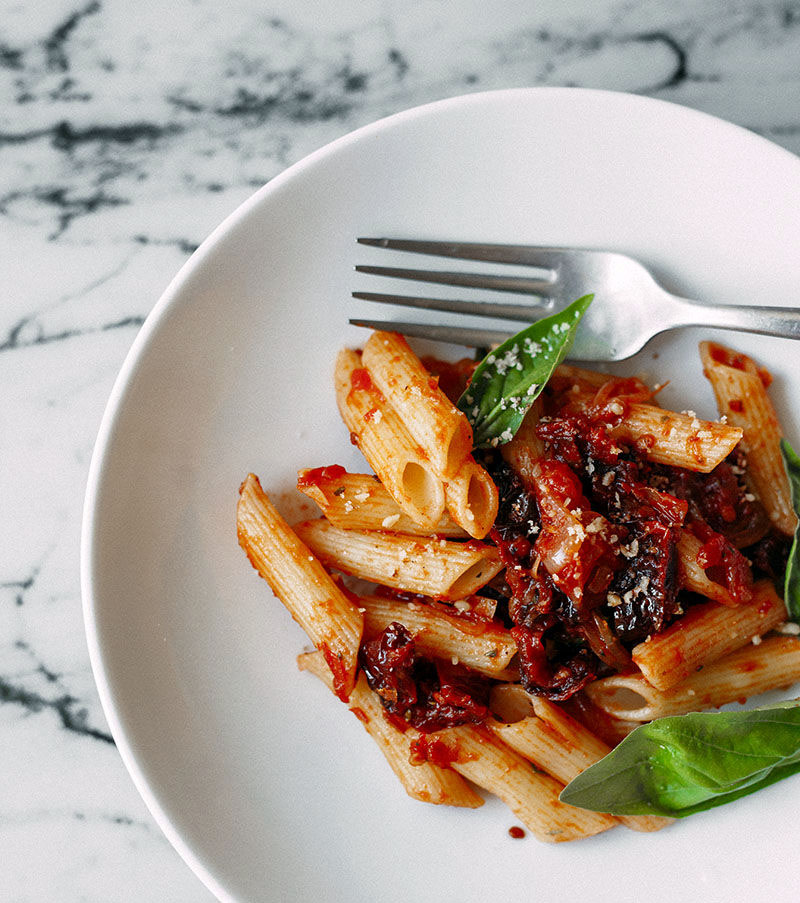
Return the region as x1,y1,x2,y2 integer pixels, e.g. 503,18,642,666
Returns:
700,342,797,536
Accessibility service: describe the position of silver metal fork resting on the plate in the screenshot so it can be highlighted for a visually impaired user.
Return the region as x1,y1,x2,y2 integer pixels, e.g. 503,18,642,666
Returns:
350,238,800,361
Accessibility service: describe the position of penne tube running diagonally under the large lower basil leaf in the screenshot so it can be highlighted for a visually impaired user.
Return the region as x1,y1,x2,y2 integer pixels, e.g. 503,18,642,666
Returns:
487,684,672,832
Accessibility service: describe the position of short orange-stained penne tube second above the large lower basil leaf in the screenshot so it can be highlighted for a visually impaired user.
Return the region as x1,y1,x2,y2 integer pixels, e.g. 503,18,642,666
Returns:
632,580,787,690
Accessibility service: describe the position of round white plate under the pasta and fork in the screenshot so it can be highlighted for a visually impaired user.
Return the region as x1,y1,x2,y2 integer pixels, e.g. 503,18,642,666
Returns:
83,88,800,903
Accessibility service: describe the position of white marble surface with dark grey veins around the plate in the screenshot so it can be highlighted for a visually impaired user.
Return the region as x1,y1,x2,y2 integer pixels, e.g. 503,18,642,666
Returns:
0,0,800,903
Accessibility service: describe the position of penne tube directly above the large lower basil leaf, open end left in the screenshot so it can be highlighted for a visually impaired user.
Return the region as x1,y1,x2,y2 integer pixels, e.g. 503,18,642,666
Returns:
586,636,800,721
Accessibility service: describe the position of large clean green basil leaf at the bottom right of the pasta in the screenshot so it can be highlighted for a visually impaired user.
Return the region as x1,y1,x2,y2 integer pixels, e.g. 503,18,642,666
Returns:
560,704,800,818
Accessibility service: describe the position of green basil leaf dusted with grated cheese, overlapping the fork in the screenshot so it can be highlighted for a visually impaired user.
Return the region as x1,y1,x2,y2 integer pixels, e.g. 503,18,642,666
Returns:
458,295,594,448
